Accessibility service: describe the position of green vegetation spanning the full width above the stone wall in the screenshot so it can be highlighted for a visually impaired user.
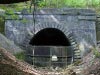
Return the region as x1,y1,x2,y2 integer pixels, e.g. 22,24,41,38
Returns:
0,0,100,14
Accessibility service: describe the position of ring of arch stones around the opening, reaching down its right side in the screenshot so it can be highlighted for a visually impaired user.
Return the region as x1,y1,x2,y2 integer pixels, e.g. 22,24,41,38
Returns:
27,23,80,61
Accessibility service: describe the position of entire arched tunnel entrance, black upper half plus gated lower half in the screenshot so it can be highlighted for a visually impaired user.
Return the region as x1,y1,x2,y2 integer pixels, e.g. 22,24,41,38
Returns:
29,28,72,67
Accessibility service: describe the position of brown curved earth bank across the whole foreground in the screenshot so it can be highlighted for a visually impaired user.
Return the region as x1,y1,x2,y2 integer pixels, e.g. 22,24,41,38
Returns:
0,48,100,75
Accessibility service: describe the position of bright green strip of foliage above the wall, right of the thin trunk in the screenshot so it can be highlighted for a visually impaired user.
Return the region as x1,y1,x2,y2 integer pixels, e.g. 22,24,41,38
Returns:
34,0,100,8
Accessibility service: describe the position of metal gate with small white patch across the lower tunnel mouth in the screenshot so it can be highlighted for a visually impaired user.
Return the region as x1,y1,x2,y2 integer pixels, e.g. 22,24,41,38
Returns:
28,46,73,67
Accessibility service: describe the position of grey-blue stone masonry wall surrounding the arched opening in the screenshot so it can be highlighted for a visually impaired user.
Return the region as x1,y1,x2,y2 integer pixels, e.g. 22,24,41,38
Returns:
5,8,96,56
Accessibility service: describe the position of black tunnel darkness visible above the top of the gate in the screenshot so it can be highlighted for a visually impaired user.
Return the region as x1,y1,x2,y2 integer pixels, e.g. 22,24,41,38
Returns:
29,28,71,46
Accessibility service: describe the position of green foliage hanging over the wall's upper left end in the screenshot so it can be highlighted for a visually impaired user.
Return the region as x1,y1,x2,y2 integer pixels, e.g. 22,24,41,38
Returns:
0,2,30,19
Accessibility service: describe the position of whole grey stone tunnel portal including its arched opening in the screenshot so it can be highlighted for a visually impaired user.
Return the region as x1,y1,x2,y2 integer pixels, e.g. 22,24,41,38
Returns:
5,8,96,68
